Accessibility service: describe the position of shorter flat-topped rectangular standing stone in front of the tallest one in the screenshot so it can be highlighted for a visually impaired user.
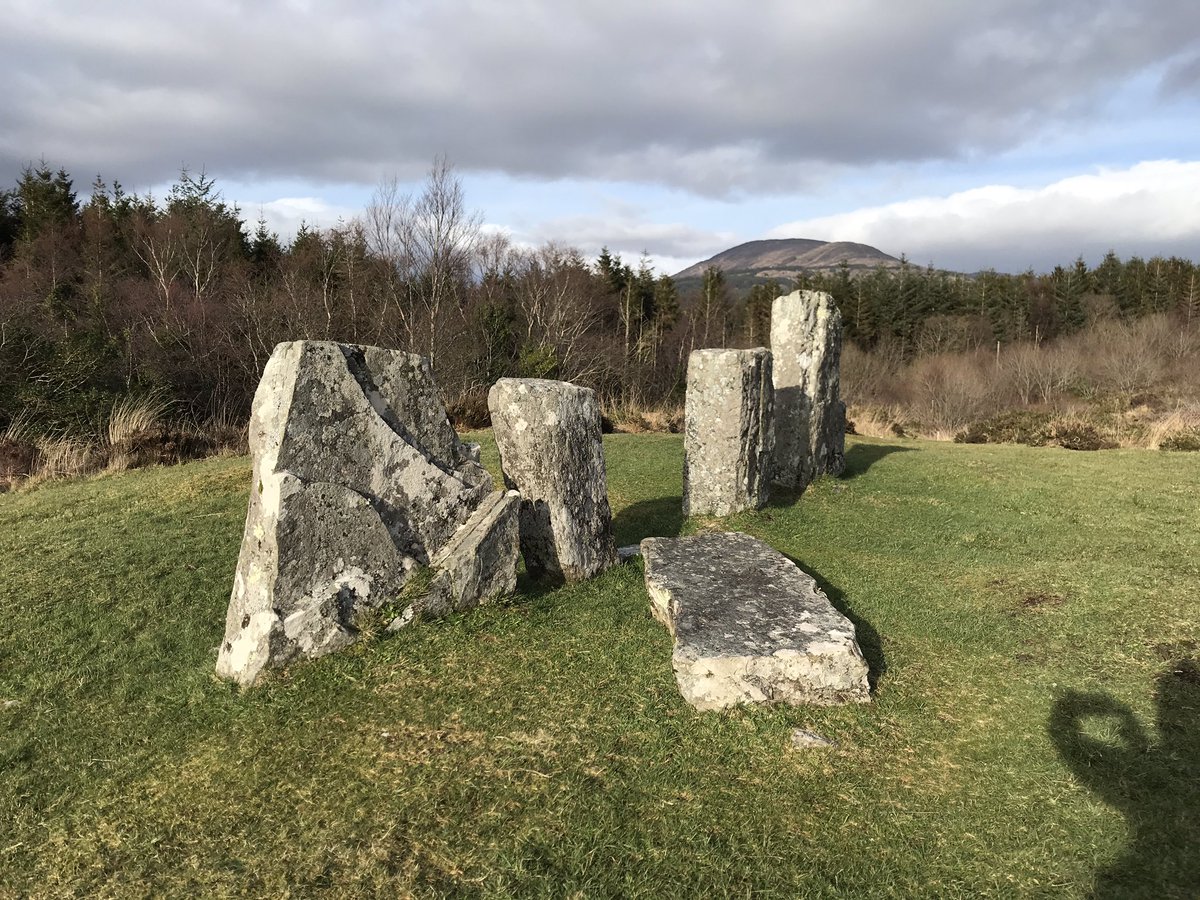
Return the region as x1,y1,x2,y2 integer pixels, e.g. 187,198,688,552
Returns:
683,347,773,516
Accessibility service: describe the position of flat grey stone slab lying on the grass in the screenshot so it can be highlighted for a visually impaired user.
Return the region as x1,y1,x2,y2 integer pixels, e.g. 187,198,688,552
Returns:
642,532,870,709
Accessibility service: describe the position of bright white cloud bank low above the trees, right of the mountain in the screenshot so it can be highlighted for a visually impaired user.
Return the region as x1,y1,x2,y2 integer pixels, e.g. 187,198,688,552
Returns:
767,160,1200,271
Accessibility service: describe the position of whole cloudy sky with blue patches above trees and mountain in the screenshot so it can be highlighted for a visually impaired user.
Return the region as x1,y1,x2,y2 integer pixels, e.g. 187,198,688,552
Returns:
0,0,1200,272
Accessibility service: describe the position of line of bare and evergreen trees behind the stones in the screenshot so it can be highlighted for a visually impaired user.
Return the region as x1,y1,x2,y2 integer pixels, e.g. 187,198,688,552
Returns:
0,160,1200,431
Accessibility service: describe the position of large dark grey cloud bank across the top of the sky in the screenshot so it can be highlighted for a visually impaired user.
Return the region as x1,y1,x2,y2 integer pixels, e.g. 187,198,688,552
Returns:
0,0,1200,197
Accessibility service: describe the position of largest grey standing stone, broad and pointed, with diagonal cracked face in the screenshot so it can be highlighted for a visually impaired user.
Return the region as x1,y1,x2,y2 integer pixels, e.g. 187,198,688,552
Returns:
217,341,492,684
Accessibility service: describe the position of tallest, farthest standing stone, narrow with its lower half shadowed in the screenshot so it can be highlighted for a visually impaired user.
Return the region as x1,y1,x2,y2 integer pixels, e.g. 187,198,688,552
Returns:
770,290,846,491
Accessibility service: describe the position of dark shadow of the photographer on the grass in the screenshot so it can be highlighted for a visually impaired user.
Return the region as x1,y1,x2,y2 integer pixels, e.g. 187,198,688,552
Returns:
1048,659,1200,898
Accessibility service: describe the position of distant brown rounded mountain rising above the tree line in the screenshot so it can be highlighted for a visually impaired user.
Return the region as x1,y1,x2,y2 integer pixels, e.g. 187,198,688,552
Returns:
674,238,900,282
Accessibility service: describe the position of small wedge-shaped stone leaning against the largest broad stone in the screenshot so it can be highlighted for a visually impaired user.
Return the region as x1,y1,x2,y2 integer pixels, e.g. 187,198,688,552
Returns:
388,491,521,631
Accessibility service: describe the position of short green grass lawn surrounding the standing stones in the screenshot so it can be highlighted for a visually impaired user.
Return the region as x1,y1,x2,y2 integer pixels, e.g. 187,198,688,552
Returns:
0,436,1200,898
